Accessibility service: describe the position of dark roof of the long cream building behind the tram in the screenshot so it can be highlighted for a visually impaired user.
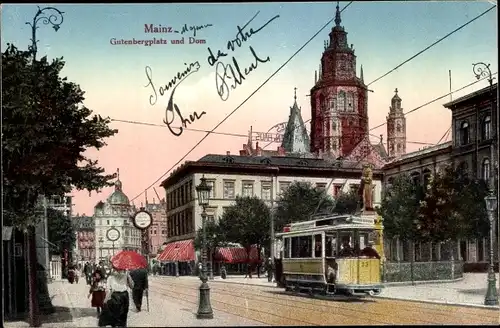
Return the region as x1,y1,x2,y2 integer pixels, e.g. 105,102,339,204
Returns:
161,154,382,187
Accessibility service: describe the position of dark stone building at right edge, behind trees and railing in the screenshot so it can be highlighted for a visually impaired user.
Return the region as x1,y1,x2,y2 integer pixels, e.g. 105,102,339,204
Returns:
383,84,498,270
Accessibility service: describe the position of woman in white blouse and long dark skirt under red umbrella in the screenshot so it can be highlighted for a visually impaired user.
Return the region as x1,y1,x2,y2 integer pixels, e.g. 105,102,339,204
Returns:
98,267,134,327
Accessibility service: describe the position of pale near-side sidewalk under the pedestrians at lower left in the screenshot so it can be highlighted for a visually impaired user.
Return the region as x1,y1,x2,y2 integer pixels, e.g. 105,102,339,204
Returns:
4,280,262,328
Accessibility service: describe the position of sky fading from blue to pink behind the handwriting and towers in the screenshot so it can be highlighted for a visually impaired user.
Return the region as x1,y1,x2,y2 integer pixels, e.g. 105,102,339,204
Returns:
1,1,498,215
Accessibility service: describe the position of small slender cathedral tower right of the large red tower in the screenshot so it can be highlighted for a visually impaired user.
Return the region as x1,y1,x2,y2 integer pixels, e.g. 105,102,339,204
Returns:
387,89,406,158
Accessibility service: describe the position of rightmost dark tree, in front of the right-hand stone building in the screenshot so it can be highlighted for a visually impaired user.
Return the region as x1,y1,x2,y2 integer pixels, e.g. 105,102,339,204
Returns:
418,165,489,242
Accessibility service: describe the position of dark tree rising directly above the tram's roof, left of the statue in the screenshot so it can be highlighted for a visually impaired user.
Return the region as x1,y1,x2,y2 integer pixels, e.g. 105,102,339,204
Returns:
274,182,335,231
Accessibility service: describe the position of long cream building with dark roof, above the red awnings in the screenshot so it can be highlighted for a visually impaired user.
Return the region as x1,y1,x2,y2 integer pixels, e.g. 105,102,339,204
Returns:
162,154,382,262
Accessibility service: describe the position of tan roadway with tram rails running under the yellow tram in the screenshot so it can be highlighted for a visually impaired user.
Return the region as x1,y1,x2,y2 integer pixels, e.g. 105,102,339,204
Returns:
150,276,500,326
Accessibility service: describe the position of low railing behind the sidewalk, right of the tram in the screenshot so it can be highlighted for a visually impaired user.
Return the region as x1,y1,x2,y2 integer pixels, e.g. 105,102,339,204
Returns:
382,261,464,282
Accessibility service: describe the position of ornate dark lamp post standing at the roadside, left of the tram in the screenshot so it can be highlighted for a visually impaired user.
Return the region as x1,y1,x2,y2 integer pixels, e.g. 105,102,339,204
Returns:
196,176,214,319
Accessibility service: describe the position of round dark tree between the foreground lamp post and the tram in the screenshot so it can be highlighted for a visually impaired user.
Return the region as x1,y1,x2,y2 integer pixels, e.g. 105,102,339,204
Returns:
219,196,271,259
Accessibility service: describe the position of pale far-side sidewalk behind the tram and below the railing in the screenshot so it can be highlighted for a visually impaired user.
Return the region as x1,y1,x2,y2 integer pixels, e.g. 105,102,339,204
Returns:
195,273,498,308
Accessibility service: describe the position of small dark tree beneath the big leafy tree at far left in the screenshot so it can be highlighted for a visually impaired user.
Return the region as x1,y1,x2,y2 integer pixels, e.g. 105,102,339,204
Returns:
47,208,76,254
